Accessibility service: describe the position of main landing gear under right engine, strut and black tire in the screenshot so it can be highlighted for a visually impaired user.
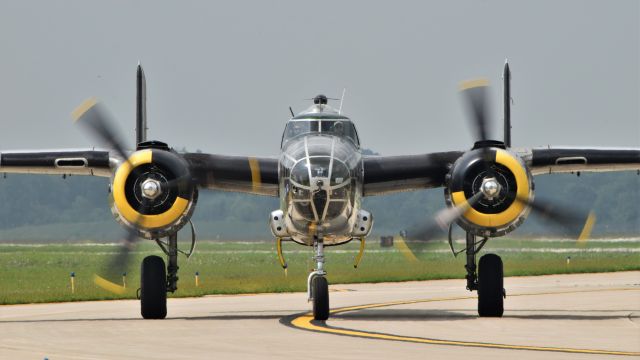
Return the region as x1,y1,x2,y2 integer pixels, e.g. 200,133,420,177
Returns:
465,232,506,317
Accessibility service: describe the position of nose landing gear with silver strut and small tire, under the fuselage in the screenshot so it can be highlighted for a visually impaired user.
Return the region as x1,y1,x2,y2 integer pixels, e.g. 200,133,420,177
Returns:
307,236,329,321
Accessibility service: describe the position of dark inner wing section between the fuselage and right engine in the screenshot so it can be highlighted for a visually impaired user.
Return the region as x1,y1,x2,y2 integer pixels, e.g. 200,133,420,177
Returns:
363,151,463,196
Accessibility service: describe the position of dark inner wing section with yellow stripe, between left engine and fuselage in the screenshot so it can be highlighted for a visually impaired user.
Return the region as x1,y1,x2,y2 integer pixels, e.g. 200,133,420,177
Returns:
182,153,278,196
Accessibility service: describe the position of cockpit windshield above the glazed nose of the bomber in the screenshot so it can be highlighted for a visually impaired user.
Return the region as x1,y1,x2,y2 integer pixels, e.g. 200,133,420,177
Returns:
282,119,360,146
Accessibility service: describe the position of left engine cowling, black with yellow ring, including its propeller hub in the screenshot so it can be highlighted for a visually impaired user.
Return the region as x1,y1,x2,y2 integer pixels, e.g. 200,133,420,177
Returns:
111,148,198,239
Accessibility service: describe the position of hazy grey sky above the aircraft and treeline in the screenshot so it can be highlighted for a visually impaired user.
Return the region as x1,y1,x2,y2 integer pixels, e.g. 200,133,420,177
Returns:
0,0,640,155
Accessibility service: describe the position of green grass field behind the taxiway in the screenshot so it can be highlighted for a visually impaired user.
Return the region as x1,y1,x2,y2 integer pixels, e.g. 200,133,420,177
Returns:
0,239,640,304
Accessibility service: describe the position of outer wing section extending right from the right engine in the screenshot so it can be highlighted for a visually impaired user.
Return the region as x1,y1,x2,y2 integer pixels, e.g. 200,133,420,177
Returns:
517,147,640,175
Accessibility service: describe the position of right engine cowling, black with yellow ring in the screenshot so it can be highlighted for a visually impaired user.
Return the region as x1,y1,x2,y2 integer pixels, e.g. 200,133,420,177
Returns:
445,147,533,237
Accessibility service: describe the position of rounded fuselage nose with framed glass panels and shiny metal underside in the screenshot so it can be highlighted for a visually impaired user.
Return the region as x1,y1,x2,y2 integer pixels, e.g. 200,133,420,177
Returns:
279,133,362,245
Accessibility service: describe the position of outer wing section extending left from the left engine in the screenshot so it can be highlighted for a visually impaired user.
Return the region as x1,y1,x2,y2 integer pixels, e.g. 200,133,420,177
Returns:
0,149,112,177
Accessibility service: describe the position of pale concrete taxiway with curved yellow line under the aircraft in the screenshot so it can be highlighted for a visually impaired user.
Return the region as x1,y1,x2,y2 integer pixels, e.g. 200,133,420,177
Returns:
0,272,640,360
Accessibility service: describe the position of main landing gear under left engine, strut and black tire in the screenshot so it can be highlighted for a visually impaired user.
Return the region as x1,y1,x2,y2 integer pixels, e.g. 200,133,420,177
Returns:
140,233,178,319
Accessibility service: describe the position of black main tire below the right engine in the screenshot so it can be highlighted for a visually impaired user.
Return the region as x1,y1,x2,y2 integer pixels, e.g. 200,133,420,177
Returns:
478,254,504,317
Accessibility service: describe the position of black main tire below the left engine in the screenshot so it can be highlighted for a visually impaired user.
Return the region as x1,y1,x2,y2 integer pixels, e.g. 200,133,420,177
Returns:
140,255,167,319
